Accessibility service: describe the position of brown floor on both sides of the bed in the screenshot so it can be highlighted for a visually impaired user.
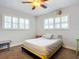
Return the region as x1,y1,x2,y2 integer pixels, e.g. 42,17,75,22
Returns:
0,46,79,59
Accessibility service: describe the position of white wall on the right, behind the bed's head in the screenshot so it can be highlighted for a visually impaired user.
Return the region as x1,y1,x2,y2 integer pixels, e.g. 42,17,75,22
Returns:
37,4,79,49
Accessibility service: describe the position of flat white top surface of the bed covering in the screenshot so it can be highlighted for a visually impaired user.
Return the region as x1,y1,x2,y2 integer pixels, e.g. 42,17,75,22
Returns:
25,38,61,47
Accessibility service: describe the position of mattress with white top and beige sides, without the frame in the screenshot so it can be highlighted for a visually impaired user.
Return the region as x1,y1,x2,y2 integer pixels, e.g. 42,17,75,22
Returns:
23,38,62,56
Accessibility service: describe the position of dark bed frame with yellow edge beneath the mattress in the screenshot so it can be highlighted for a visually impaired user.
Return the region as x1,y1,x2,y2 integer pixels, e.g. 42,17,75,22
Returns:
21,44,62,59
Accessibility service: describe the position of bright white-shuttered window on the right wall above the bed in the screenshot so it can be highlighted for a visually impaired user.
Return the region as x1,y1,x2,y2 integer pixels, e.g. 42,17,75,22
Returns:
44,16,69,29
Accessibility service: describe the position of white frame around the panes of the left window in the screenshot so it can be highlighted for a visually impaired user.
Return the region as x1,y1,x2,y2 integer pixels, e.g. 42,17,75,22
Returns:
1,15,30,31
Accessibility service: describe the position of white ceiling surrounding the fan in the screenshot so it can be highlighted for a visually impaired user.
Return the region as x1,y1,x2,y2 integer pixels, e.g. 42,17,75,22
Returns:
0,0,78,16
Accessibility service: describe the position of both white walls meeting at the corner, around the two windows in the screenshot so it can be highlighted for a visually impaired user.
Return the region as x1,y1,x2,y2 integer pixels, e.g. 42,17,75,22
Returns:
0,4,79,49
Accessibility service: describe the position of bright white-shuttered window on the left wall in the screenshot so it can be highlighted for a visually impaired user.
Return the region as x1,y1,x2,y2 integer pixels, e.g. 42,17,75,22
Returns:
4,16,29,29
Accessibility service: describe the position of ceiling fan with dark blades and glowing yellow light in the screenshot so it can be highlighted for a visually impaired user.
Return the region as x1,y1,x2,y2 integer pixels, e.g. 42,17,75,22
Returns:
22,0,48,10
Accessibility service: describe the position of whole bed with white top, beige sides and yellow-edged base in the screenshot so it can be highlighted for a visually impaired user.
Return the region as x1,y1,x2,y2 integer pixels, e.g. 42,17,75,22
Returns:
22,37,62,59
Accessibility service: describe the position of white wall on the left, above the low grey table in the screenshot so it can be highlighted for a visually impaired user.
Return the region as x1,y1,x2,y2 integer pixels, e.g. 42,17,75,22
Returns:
0,6,36,46
